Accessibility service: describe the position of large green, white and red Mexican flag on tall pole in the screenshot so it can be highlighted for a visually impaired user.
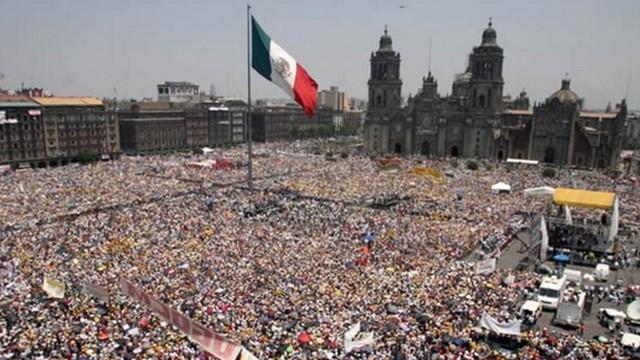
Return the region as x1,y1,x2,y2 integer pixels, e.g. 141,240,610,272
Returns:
251,16,318,117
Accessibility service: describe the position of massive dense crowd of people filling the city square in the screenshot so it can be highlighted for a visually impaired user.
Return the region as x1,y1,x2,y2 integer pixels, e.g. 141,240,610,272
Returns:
0,144,640,359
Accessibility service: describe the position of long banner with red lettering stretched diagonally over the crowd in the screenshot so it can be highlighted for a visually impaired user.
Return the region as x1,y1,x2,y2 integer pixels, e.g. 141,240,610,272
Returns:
120,279,242,360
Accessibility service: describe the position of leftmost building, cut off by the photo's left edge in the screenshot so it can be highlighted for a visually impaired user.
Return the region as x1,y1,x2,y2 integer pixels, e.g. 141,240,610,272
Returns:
0,95,47,167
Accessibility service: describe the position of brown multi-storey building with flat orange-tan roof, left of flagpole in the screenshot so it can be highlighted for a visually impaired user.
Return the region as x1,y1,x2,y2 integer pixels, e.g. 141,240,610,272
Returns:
32,97,120,165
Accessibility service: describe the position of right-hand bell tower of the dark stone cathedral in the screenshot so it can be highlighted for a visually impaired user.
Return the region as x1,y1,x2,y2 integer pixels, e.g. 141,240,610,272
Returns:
469,20,504,112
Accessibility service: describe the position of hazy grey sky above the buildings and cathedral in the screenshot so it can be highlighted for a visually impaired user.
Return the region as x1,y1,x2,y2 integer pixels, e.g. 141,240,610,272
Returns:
0,0,640,108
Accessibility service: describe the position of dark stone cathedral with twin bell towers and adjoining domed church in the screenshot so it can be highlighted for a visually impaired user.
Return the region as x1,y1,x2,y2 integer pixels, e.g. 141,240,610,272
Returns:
363,22,627,168
